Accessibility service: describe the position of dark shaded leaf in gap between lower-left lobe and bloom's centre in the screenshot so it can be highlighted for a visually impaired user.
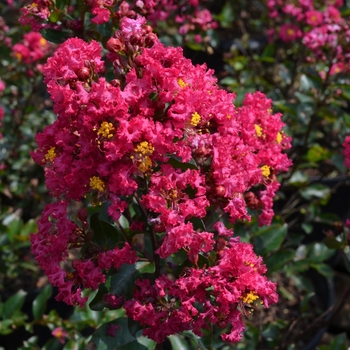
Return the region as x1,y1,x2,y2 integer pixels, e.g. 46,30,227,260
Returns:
90,213,124,250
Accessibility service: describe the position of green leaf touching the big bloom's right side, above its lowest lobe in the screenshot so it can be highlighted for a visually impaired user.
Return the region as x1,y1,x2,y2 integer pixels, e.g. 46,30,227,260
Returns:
254,224,287,256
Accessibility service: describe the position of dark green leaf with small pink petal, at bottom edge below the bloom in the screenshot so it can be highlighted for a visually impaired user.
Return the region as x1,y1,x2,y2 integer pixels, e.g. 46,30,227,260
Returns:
89,317,156,350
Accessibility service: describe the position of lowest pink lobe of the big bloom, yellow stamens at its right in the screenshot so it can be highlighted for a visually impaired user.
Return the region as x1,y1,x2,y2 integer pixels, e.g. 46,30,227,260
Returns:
124,238,278,343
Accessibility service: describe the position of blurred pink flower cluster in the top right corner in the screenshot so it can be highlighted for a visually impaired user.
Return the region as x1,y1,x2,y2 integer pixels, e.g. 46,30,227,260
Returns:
267,0,350,75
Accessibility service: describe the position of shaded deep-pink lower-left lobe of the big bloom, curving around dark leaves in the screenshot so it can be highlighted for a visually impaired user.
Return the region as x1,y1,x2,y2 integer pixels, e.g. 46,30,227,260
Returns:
31,201,137,306
